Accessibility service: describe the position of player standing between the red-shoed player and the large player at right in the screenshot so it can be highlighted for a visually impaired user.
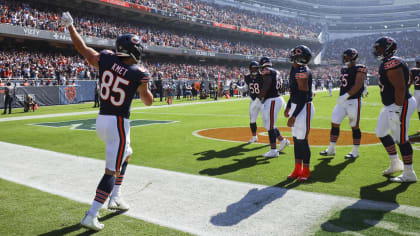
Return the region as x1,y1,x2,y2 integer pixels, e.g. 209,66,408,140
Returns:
319,48,367,158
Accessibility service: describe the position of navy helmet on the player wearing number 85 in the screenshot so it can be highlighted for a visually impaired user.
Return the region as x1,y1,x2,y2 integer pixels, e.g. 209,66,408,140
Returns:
115,34,143,62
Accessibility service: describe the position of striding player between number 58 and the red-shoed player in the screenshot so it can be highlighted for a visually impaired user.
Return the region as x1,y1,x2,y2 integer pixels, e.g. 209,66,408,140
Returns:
250,57,290,157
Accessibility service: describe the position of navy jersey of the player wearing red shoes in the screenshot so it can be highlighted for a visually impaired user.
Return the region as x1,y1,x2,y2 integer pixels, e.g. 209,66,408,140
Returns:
289,66,312,104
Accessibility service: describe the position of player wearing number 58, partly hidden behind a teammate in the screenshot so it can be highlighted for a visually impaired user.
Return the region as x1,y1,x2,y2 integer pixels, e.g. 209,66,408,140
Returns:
245,61,263,143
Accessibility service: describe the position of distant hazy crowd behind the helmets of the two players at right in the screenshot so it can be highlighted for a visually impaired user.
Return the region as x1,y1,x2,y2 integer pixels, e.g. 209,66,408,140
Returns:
324,31,420,65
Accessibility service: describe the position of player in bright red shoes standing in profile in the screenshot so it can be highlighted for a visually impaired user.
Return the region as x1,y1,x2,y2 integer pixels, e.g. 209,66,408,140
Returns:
284,45,315,181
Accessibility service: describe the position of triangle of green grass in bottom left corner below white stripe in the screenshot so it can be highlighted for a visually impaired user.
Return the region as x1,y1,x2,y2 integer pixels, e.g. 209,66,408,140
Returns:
0,179,190,236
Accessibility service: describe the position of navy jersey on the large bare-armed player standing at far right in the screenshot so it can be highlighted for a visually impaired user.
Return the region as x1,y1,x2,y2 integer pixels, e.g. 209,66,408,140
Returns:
379,57,411,106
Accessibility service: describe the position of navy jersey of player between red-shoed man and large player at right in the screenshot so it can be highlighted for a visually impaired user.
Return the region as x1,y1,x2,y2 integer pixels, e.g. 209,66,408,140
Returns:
340,65,367,99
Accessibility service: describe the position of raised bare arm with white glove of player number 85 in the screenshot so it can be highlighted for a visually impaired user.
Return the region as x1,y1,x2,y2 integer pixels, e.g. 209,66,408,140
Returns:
61,12,99,69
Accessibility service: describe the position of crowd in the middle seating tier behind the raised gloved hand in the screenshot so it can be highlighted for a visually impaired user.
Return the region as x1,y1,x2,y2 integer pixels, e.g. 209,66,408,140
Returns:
0,0,294,58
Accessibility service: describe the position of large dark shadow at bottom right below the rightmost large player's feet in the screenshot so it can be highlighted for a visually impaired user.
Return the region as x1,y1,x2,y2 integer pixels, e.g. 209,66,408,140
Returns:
321,180,418,234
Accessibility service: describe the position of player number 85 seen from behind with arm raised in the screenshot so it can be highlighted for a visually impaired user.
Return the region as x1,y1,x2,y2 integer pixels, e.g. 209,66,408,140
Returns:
61,12,153,230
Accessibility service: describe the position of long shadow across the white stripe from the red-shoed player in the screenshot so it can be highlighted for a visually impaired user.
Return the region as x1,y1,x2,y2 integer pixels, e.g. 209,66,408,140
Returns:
210,179,300,226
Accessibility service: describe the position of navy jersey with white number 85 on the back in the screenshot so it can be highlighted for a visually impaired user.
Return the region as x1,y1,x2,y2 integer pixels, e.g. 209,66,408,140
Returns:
99,50,150,118
